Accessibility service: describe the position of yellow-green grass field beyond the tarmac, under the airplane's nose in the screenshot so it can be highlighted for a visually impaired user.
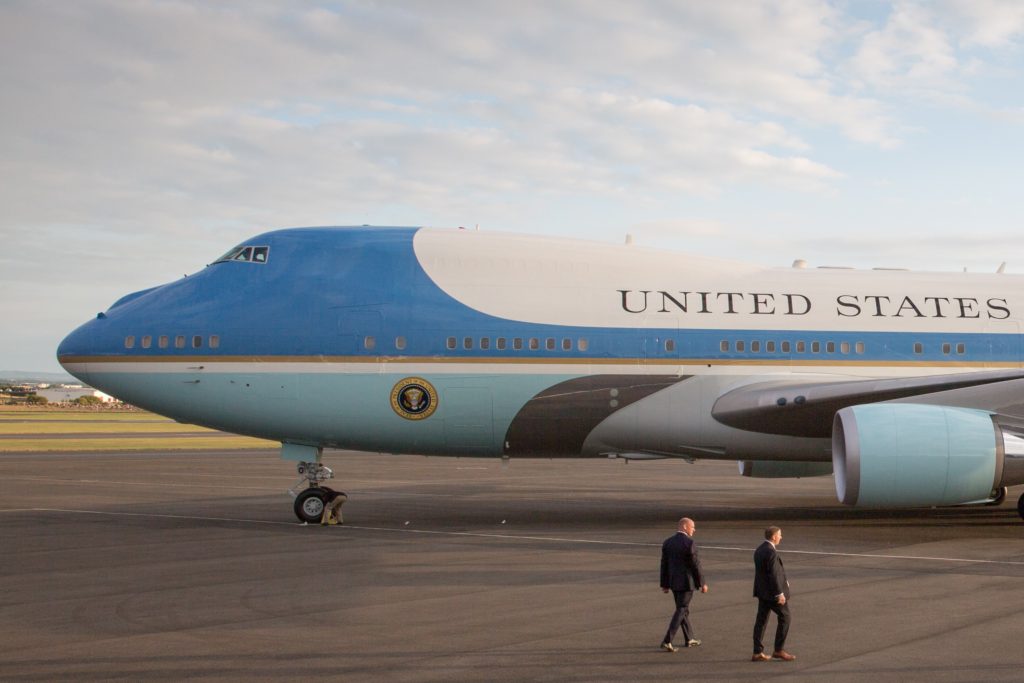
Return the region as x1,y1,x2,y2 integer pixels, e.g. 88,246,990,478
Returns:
0,405,279,453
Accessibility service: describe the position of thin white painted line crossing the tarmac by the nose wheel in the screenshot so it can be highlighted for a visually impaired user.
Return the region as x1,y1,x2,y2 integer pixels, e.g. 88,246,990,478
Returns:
6,508,1024,566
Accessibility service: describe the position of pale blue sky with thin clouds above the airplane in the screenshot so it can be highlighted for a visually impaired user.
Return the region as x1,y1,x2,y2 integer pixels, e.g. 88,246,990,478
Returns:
0,0,1024,372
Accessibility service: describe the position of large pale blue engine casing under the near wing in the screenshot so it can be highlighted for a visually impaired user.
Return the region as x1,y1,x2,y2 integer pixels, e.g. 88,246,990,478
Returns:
833,403,1006,507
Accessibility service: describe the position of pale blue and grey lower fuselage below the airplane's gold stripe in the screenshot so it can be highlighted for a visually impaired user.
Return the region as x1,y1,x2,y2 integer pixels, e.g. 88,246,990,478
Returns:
94,365,829,461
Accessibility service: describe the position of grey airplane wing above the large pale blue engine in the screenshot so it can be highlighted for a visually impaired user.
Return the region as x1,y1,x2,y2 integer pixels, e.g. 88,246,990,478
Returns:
712,370,1024,438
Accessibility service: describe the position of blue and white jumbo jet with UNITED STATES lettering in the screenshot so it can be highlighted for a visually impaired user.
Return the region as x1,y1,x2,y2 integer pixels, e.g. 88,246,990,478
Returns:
57,226,1024,522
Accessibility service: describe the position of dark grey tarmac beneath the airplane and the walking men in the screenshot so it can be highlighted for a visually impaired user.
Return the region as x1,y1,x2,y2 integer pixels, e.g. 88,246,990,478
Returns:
0,451,1024,683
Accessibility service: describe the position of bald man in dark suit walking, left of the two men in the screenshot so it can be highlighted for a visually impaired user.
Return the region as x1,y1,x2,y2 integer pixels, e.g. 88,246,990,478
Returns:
662,517,708,652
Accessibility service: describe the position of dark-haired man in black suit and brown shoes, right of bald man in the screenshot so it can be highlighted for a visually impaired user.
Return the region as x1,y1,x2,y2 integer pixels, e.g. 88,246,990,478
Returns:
751,526,797,661
